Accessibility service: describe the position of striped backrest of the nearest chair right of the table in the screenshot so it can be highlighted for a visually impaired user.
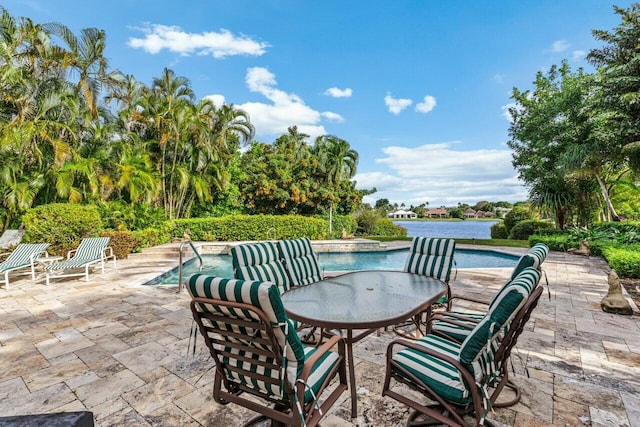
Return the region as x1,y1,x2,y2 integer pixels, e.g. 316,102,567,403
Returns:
460,267,542,382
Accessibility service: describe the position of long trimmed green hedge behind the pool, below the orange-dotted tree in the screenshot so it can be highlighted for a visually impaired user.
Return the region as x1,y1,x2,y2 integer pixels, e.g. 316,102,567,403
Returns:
172,215,329,242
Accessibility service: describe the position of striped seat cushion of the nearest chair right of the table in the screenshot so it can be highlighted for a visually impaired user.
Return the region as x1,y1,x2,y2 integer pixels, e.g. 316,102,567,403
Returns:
392,335,470,405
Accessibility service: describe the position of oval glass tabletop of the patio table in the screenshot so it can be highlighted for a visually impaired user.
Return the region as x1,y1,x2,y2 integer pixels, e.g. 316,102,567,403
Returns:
282,270,447,329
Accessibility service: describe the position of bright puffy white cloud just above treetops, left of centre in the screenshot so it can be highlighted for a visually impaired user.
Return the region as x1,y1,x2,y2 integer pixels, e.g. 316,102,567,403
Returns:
237,67,330,139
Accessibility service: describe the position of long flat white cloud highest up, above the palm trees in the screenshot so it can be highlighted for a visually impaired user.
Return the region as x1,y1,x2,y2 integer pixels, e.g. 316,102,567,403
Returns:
127,24,269,58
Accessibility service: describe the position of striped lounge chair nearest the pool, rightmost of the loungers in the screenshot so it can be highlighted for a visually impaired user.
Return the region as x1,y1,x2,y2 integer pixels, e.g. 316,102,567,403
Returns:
45,237,116,286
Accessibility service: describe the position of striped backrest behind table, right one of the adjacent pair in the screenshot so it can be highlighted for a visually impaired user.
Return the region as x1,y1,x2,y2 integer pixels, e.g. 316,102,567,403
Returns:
278,237,322,286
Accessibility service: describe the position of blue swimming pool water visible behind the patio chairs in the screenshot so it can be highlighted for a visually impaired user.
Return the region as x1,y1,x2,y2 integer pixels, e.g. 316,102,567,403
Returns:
145,249,518,285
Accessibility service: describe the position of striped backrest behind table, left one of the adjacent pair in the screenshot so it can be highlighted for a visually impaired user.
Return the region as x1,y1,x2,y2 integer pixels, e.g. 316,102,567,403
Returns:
231,242,291,293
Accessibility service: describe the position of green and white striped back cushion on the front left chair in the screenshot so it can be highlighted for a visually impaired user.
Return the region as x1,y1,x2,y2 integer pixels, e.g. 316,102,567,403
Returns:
187,274,305,397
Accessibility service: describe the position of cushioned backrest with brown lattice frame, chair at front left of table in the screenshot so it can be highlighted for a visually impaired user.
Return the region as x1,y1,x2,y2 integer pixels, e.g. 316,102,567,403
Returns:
188,274,304,398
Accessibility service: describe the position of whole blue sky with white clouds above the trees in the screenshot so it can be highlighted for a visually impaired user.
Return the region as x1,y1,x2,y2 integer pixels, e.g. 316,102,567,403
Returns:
3,0,631,207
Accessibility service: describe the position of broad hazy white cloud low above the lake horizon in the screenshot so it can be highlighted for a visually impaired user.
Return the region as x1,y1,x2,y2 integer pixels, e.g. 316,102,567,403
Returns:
355,142,527,207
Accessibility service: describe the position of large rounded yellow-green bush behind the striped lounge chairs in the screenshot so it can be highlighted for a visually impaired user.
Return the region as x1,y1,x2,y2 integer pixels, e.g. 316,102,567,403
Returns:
22,203,103,255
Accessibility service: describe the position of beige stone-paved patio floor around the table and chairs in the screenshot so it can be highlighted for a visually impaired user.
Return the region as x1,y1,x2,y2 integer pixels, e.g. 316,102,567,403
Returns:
0,248,640,427
